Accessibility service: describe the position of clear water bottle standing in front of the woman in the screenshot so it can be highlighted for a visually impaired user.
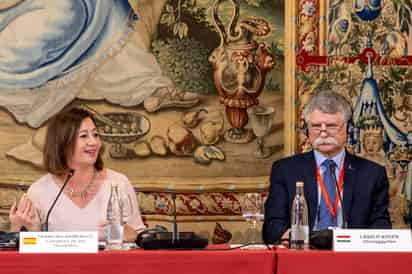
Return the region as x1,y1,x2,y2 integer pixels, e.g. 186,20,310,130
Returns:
105,185,123,249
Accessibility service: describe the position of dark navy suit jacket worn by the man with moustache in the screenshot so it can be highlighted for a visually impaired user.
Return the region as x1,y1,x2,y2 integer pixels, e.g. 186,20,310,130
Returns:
263,151,391,243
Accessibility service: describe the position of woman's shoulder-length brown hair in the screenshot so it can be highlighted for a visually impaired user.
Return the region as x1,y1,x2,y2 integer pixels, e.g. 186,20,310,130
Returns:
43,108,103,176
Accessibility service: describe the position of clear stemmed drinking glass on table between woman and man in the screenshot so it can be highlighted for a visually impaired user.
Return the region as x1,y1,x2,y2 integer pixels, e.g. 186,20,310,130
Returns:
242,192,263,244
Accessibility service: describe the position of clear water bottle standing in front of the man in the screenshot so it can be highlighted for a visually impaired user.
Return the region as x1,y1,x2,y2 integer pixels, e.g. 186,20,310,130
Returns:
290,182,309,249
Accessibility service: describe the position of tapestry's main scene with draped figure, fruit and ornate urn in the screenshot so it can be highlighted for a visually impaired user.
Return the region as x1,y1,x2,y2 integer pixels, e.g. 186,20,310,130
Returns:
0,0,283,183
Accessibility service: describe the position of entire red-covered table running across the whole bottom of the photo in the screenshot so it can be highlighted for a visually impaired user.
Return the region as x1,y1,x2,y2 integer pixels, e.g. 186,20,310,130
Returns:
0,245,412,274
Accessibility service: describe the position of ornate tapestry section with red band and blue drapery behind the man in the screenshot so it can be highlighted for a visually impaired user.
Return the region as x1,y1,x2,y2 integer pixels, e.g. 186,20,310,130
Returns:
286,0,412,228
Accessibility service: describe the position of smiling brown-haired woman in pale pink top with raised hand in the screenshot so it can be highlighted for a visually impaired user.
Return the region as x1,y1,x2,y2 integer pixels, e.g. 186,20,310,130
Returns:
10,108,145,241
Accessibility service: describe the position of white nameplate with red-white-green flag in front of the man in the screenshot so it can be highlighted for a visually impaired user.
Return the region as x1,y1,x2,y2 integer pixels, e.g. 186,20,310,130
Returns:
333,229,412,252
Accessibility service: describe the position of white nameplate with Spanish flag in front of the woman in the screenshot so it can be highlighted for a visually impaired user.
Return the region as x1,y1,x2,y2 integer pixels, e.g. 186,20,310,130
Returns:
19,232,98,253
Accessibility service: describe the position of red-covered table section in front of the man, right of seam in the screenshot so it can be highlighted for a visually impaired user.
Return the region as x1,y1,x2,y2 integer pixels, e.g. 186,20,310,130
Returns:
276,248,412,274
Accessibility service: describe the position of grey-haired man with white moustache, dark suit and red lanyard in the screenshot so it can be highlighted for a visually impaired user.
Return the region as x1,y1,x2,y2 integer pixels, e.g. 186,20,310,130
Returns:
263,91,391,243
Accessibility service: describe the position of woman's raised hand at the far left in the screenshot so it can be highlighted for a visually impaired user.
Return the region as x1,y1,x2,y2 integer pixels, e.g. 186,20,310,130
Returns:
9,194,36,231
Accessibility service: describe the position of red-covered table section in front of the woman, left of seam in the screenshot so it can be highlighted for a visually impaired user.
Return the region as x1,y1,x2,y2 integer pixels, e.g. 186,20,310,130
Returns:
0,249,275,274
